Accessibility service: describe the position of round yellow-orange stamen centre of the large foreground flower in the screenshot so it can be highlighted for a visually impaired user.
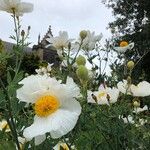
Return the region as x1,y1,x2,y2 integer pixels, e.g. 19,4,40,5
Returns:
34,96,60,117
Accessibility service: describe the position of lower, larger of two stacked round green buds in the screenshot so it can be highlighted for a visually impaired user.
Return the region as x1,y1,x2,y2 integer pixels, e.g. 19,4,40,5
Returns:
76,65,88,83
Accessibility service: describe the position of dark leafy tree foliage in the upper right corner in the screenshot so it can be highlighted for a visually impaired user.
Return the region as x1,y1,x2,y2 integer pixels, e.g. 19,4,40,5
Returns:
102,0,150,80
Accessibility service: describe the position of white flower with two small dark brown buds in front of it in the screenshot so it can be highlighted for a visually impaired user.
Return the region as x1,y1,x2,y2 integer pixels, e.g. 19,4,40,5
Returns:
88,86,119,105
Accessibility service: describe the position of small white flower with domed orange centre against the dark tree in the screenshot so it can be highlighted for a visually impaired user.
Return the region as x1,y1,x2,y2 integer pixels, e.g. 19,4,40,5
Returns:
114,41,134,53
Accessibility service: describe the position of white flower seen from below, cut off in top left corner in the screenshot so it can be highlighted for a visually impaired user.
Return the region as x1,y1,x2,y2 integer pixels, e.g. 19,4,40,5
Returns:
0,0,33,16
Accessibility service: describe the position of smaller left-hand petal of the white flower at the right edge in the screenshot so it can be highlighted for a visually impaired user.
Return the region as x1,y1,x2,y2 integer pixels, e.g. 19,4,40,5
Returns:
117,80,131,95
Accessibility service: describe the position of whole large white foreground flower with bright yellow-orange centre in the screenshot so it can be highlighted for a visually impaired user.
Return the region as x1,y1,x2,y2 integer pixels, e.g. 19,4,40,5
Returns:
17,75,81,143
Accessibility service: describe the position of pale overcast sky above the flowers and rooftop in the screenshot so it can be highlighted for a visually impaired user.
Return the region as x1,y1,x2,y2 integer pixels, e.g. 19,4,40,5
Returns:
0,0,113,44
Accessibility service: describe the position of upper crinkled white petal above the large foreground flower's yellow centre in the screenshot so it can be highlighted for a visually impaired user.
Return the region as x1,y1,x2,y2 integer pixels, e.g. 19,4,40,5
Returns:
17,75,80,103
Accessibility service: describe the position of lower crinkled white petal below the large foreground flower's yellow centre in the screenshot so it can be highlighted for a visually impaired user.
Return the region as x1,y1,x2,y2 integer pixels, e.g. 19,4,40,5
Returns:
23,100,81,138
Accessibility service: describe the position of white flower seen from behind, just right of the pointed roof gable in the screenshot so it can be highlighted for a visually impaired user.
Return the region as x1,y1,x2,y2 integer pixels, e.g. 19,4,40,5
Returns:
46,31,72,50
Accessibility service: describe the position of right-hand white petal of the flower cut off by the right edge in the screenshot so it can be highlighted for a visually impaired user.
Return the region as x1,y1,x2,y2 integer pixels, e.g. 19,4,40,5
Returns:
131,81,150,97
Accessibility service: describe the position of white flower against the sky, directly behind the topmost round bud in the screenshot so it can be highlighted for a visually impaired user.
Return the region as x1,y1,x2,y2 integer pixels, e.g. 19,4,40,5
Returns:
80,31,103,51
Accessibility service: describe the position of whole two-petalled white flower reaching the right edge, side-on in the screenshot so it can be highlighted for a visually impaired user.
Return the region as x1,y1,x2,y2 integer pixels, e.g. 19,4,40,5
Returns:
117,80,150,97
